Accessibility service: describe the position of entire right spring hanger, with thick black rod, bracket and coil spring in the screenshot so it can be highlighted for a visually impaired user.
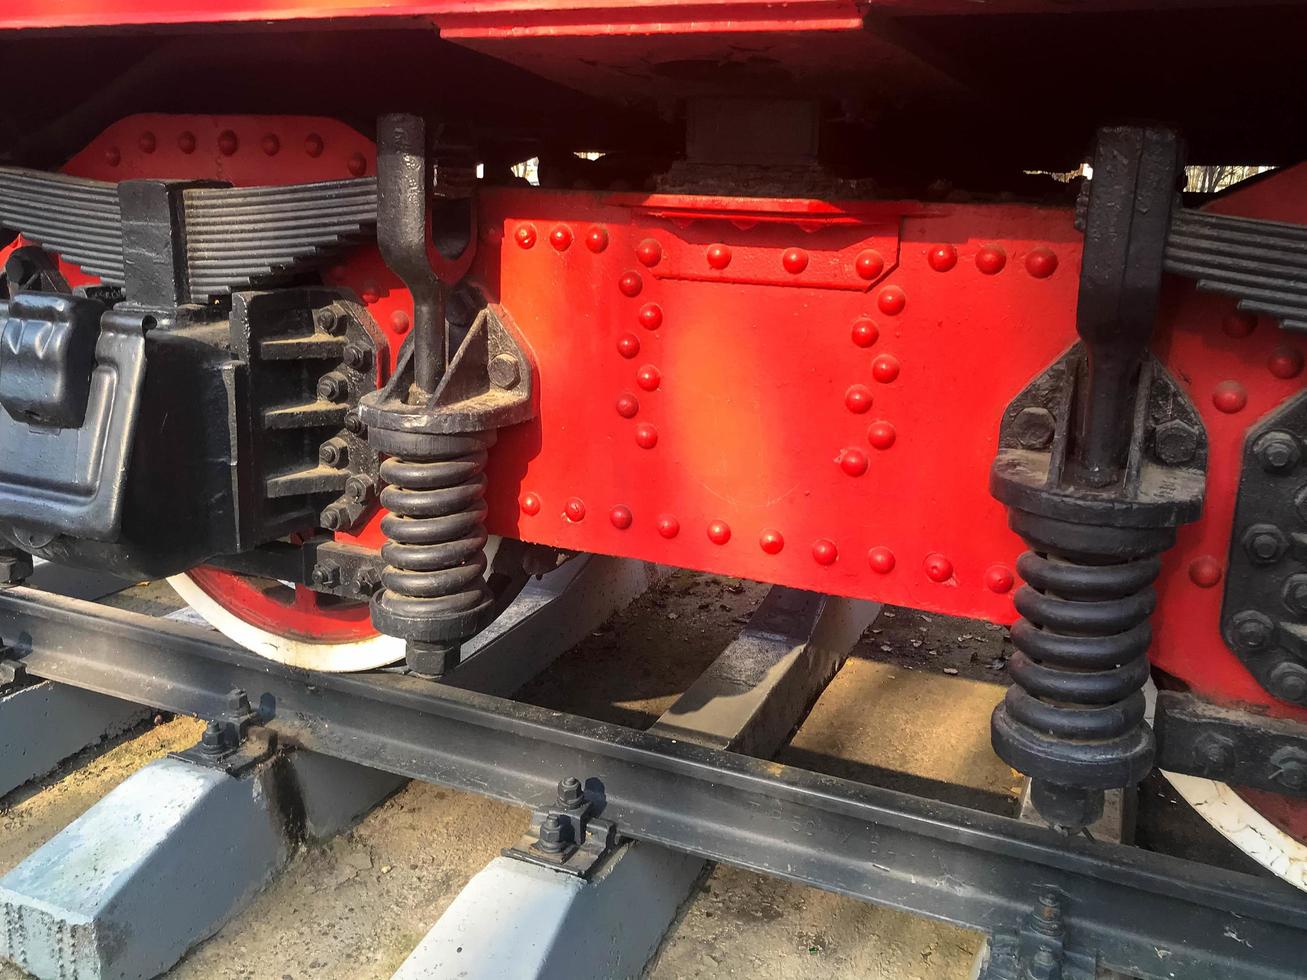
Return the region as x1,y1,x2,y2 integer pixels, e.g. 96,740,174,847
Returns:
989,128,1208,832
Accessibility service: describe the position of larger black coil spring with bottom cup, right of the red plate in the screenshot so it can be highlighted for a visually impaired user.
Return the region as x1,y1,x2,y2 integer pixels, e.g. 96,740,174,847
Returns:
993,515,1167,789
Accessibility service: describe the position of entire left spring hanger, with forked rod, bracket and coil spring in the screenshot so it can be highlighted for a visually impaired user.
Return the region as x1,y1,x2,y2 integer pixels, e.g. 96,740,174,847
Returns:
359,115,535,677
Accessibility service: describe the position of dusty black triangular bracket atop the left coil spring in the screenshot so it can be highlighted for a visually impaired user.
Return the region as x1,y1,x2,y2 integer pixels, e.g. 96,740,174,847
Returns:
358,297,536,438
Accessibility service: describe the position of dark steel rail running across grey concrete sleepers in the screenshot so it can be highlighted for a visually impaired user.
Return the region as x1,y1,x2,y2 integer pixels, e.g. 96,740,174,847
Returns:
0,588,1307,979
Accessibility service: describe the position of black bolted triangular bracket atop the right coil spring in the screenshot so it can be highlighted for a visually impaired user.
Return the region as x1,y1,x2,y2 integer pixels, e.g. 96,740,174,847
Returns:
989,344,1208,528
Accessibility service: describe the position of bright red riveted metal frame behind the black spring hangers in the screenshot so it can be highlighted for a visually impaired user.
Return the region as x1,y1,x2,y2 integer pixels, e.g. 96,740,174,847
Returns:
10,116,1307,717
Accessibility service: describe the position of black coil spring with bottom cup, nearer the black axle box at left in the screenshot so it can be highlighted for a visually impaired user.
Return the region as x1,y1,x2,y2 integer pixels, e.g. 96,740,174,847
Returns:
372,435,491,653
